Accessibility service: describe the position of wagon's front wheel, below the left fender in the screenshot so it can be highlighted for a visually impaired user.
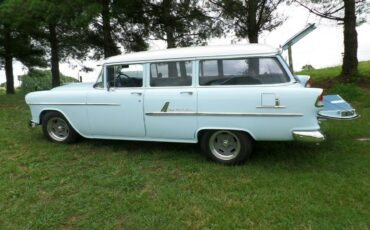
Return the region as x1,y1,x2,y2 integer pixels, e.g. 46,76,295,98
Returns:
42,111,78,143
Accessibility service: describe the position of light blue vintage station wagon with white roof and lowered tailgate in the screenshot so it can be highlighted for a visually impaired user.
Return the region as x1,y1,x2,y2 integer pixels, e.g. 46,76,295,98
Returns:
26,45,357,164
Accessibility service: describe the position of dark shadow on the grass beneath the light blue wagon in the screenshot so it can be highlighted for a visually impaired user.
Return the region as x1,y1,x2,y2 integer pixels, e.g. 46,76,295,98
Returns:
76,136,327,168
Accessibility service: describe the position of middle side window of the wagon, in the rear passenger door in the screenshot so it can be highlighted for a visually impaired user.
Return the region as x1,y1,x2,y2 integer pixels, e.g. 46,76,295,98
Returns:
150,61,192,87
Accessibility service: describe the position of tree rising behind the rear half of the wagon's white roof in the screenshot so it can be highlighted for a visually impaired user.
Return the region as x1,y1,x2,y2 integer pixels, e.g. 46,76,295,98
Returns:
209,0,285,43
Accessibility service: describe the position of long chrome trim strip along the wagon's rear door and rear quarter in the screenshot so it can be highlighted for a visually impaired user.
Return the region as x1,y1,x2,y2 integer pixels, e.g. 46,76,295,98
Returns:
145,112,303,117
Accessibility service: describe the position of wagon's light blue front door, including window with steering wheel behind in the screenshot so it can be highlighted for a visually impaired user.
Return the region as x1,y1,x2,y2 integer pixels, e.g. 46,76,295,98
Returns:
87,64,145,139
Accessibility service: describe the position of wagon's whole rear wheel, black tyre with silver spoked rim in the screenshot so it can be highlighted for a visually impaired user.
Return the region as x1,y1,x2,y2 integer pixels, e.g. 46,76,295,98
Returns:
200,130,252,165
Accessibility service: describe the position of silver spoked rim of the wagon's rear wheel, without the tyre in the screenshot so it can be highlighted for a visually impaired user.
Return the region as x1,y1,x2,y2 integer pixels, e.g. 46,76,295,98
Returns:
209,130,241,160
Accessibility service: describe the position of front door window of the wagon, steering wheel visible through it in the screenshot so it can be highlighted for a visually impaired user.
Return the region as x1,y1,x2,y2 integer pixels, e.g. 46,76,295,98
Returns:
107,64,144,88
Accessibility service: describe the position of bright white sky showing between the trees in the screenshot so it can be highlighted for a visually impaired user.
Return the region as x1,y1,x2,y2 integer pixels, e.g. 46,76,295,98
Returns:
0,5,370,86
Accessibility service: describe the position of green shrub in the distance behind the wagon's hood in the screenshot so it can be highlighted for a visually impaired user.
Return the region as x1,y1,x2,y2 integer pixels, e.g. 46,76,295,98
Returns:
21,70,78,92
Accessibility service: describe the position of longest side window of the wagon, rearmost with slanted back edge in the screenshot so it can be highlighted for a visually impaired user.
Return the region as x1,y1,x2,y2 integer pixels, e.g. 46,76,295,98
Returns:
199,57,290,86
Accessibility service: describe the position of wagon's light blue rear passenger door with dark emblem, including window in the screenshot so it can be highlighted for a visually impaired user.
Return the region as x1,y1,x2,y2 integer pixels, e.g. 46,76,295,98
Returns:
144,61,197,140
